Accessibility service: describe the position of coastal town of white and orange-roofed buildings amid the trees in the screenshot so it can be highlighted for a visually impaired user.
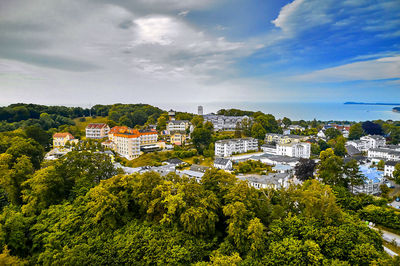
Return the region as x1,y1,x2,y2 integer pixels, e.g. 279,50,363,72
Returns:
46,106,400,198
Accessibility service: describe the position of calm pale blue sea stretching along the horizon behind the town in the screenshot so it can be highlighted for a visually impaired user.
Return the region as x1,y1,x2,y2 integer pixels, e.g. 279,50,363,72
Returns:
154,102,400,122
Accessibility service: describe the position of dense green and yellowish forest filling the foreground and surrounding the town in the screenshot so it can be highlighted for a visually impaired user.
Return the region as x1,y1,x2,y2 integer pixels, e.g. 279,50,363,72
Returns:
0,104,400,265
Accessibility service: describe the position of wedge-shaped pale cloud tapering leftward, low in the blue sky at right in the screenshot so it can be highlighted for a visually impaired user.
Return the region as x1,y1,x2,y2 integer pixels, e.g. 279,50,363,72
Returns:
293,56,400,82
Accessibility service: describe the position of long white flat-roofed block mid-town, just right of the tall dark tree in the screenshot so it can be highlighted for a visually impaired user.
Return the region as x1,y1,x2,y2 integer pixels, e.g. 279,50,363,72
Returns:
215,138,258,157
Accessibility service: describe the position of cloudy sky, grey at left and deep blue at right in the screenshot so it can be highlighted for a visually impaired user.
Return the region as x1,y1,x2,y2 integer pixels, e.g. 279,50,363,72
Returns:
0,0,400,106
